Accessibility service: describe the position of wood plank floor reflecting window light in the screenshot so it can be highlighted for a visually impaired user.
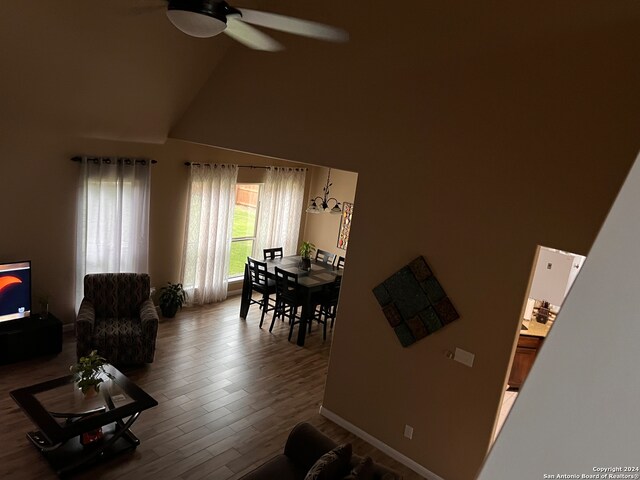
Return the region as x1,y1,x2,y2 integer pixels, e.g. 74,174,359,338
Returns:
0,297,422,480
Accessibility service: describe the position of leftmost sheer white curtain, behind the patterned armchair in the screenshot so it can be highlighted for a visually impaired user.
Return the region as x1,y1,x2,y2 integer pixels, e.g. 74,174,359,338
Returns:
76,157,151,309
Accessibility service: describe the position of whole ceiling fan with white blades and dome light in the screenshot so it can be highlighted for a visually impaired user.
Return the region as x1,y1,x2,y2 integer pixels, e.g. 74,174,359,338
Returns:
160,0,349,52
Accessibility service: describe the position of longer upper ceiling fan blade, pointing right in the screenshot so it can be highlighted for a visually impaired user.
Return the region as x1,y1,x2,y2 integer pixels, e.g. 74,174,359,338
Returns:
238,8,349,42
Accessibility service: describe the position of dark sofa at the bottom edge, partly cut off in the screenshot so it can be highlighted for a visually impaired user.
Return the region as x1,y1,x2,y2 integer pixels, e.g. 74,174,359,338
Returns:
241,422,402,480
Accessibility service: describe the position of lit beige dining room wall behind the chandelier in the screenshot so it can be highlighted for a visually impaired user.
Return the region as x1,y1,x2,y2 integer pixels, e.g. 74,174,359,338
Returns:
303,167,358,257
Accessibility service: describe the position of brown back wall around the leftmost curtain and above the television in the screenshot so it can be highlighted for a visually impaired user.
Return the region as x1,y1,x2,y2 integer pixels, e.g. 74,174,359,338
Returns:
0,136,306,323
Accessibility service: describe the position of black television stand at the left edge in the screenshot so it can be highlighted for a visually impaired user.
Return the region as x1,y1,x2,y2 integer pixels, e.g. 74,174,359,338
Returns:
0,313,62,365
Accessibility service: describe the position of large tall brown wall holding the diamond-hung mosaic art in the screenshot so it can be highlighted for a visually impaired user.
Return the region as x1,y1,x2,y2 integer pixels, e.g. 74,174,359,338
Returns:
172,0,640,480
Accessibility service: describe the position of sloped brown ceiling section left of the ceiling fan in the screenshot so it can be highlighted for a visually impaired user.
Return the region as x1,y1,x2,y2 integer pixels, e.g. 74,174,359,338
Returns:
0,0,252,142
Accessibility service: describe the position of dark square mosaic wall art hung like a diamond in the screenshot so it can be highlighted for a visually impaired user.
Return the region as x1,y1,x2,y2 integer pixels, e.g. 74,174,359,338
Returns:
373,256,460,347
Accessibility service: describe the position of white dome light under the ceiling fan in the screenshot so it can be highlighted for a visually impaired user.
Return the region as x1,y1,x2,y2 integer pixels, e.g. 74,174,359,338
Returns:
167,0,230,38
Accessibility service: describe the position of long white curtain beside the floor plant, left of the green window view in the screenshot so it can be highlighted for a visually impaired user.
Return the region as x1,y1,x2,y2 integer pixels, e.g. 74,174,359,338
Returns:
181,164,238,305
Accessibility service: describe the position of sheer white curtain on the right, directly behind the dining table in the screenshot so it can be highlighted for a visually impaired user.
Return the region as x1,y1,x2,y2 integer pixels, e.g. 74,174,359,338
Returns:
256,167,306,255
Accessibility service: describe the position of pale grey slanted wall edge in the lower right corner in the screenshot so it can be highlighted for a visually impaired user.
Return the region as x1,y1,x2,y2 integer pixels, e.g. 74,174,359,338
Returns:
479,150,640,480
